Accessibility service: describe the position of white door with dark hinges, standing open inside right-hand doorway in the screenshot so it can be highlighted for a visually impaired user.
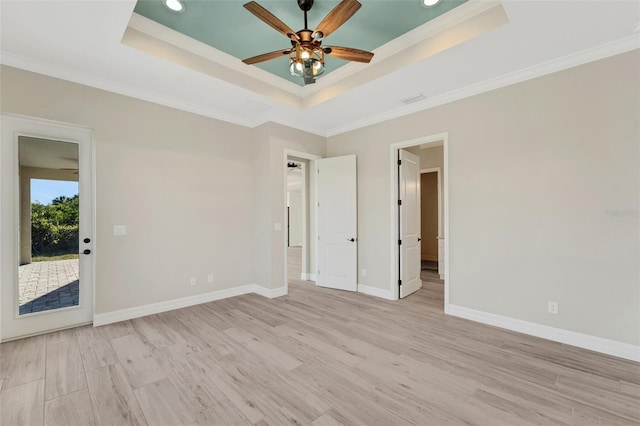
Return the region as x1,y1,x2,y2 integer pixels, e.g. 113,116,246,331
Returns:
398,149,422,298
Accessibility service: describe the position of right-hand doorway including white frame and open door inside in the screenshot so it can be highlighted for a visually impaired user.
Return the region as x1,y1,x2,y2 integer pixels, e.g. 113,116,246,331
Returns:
390,133,449,311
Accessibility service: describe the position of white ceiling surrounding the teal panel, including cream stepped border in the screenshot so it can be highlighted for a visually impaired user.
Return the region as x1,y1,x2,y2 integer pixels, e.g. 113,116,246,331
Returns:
0,0,640,136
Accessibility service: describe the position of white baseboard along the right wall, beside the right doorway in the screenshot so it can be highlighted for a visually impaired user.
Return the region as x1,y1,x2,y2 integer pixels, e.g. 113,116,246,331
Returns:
445,304,640,362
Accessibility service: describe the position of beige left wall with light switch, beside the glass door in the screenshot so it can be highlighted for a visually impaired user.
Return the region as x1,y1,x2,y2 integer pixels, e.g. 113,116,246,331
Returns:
1,67,255,313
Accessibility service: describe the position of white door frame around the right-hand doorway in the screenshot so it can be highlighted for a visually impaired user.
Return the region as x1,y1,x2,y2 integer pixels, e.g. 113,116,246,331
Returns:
389,132,451,306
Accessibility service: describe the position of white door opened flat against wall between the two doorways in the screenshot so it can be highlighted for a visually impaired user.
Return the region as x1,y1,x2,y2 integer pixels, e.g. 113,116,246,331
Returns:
316,155,358,291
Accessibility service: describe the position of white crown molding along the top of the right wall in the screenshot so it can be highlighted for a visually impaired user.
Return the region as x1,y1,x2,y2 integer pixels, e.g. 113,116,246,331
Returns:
324,34,640,137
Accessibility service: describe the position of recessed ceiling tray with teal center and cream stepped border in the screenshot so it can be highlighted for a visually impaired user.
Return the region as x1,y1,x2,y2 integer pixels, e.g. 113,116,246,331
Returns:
122,0,508,109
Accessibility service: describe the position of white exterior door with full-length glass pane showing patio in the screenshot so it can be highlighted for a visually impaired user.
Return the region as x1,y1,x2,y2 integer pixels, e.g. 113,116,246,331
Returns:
0,115,94,341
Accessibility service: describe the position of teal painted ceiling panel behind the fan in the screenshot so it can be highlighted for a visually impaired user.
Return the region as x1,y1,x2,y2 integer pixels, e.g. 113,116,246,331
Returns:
134,0,468,85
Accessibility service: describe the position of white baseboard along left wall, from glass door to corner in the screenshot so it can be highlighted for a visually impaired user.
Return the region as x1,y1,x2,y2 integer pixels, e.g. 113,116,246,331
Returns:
93,284,287,327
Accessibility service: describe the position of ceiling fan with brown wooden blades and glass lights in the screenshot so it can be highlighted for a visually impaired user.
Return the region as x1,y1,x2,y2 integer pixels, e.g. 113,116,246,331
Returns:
242,0,373,84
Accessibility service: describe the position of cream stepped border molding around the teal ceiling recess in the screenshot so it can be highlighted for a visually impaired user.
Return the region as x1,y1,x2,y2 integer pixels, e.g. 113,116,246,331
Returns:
122,0,509,109
